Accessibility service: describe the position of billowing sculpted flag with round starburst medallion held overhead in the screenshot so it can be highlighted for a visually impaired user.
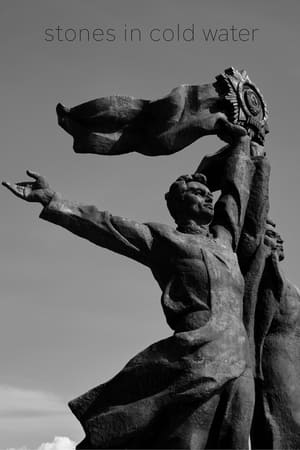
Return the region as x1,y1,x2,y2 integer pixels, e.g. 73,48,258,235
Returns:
57,68,268,156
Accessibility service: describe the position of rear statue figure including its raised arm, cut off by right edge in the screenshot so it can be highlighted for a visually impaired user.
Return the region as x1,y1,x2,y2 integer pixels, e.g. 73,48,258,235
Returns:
232,147,300,450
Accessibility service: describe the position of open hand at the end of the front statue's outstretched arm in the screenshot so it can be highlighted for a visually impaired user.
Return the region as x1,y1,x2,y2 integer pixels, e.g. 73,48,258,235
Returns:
2,170,54,206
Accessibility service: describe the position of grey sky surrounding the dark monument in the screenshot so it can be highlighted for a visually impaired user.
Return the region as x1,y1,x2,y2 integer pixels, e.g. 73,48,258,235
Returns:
0,0,300,450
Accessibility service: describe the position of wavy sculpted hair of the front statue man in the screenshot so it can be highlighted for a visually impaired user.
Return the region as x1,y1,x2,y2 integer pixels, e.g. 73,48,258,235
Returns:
165,173,207,223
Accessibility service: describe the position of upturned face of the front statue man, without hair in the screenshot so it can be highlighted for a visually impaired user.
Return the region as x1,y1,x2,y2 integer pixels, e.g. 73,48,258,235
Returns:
183,181,214,224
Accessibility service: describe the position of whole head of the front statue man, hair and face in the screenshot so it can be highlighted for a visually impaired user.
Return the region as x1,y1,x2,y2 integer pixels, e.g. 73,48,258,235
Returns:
165,173,214,225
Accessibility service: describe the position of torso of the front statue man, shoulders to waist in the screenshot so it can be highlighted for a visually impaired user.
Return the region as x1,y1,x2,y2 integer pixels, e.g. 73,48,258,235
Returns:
150,226,243,331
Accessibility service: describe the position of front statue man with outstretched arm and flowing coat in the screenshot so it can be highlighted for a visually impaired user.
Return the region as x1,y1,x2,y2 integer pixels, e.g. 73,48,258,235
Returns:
4,132,255,450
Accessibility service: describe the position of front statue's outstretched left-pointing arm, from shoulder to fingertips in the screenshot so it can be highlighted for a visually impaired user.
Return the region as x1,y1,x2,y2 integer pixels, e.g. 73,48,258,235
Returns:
3,171,153,265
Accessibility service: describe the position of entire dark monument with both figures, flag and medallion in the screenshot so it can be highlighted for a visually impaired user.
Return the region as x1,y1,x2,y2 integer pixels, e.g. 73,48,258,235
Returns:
3,68,300,450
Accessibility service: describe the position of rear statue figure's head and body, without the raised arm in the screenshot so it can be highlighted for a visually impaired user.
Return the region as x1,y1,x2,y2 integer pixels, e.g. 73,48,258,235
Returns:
251,221,300,450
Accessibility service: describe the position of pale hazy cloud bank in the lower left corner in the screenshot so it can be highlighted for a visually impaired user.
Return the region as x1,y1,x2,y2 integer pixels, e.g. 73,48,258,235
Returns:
0,384,83,450
